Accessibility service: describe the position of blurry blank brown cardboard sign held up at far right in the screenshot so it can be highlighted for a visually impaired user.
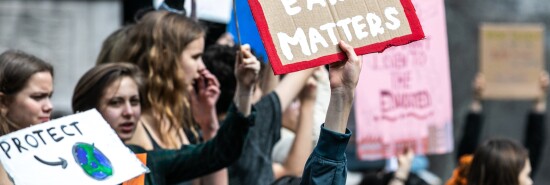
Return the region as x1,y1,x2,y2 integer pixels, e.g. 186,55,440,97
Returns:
479,24,544,99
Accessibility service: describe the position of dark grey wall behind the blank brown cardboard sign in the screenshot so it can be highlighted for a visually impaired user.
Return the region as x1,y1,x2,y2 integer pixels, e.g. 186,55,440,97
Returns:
436,0,550,185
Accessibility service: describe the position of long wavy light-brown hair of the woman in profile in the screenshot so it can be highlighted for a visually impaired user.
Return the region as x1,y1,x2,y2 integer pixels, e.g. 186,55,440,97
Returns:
121,11,205,147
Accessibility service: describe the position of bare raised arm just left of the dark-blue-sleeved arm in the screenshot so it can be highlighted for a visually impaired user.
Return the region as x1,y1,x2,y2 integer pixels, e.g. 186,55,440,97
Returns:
273,77,317,179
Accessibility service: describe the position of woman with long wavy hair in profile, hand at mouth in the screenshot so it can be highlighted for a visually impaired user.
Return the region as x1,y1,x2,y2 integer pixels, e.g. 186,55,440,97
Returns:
106,11,266,184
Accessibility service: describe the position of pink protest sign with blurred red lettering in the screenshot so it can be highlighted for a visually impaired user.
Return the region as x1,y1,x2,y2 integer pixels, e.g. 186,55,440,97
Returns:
355,0,453,160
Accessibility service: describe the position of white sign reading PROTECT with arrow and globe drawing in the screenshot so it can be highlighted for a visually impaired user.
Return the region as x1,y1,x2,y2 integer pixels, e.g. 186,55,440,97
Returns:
0,110,148,185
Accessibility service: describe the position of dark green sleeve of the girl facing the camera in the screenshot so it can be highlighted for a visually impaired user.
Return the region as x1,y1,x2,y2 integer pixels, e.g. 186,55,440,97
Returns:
130,105,256,184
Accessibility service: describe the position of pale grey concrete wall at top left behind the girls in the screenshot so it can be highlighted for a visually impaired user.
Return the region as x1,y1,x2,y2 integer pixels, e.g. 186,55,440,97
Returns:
0,0,121,113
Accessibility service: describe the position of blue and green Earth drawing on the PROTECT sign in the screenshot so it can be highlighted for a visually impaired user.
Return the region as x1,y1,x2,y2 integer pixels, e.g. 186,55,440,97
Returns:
72,143,113,180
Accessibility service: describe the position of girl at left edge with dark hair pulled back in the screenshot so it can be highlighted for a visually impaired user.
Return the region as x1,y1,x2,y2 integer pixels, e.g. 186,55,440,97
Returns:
0,50,53,185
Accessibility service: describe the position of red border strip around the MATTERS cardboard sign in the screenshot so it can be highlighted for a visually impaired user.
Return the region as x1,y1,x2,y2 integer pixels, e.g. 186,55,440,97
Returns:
248,0,425,75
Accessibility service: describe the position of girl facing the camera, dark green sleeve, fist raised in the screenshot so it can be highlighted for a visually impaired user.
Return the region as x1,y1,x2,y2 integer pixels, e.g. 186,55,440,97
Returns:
72,61,259,185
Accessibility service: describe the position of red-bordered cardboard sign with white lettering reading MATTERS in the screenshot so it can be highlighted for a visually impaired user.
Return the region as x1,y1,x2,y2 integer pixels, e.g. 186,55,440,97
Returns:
249,0,424,74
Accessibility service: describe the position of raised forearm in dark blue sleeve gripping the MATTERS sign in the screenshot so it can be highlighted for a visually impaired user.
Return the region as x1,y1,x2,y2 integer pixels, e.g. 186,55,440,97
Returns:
301,42,361,184
